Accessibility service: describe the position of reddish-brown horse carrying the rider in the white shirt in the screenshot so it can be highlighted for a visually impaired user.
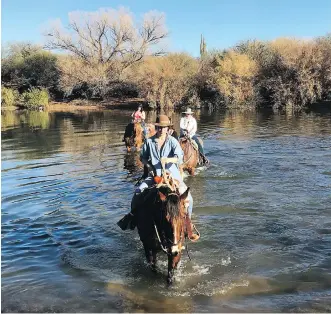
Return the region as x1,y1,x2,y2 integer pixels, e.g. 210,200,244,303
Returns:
179,136,203,176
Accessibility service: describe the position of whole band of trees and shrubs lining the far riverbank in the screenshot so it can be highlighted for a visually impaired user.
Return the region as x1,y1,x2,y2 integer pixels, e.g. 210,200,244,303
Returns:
1,9,331,110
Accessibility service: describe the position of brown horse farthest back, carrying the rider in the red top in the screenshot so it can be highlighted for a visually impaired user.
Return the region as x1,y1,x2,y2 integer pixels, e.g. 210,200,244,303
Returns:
123,122,155,152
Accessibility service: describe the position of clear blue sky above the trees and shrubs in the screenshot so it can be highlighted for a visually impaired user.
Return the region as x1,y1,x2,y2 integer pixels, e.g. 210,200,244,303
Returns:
1,0,331,56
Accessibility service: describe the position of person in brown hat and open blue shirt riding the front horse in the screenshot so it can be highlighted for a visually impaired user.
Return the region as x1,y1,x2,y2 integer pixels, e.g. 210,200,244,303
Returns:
118,115,199,241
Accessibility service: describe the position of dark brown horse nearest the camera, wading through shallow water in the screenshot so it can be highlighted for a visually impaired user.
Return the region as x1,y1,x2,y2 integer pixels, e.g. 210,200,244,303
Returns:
136,182,189,284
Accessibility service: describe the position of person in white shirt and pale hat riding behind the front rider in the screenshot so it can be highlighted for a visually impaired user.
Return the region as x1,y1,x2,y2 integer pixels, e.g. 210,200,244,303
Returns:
180,108,209,164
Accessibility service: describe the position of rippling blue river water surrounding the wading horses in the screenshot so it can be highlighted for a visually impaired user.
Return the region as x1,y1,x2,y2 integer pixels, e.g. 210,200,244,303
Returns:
1,111,331,312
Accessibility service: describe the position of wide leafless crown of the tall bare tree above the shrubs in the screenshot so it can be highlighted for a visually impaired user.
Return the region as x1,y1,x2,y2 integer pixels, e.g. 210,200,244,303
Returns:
45,8,167,78
